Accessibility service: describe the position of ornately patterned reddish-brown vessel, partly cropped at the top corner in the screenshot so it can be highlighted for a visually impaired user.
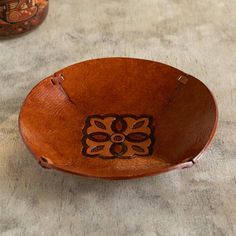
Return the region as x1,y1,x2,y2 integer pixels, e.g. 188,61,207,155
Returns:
0,0,48,37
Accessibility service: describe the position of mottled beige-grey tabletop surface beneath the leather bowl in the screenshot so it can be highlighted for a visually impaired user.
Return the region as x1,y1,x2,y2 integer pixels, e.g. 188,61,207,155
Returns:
0,0,236,236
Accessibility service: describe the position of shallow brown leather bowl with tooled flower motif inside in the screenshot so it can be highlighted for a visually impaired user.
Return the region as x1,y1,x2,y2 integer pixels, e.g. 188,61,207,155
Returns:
19,58,217,179
